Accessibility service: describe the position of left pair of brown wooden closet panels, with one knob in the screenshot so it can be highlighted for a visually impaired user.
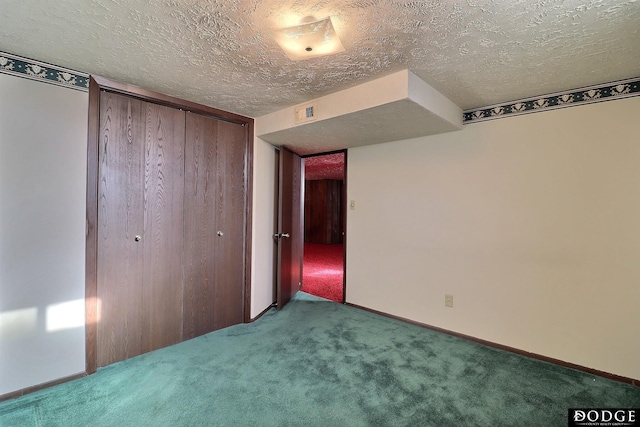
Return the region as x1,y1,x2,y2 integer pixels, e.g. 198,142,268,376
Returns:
96,92,185,367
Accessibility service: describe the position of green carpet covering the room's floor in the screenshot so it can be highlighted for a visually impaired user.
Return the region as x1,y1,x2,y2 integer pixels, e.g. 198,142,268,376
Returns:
0,293,640,427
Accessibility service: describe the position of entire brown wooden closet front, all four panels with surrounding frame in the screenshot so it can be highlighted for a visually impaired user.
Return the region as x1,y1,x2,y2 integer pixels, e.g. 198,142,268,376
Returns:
86,77,252,372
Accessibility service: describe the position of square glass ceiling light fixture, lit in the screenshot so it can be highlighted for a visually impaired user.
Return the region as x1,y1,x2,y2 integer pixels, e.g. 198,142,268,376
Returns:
273,17,344,61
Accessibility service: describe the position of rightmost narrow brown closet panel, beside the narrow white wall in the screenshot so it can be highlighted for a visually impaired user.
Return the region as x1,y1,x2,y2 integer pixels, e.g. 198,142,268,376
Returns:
213,121,247,329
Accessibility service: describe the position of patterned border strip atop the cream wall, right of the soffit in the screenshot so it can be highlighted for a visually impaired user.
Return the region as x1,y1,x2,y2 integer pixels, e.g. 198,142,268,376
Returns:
463,77,640,124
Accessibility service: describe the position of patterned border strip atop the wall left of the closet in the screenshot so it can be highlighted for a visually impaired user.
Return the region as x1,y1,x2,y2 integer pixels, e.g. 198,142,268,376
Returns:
0,52,89,92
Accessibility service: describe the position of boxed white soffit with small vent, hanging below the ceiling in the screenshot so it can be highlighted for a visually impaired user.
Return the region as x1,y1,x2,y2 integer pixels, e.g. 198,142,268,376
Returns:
255,70,463,155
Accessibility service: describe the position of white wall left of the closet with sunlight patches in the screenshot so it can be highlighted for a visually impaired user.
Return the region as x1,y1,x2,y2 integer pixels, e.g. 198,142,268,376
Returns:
0,74,88,395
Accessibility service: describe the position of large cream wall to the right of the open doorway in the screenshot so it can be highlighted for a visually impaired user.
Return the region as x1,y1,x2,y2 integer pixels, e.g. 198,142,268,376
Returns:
347,97,640,379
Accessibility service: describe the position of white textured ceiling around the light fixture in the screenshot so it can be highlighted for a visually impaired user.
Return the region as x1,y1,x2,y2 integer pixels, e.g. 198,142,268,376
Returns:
0,0,640,117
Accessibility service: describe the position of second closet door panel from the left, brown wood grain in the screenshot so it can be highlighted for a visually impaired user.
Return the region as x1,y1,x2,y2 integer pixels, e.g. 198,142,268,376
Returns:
141,103,185,352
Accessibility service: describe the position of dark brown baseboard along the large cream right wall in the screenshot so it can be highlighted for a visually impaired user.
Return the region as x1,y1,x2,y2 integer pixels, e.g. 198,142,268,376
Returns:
345,302,640,387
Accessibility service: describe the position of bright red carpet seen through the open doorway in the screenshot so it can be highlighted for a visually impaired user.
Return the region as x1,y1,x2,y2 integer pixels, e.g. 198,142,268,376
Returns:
302,243,343,302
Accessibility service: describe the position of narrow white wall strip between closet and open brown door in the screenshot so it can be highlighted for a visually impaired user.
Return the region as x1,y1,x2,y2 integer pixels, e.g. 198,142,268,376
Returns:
251,138,276,319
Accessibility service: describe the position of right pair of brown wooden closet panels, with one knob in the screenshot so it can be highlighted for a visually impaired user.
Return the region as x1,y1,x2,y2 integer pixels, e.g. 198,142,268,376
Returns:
183,113,247,339
